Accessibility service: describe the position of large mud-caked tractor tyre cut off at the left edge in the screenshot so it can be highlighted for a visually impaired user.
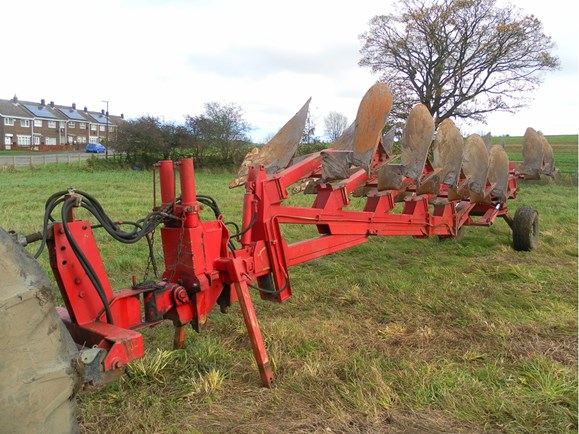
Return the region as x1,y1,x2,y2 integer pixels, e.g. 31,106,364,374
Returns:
0,228,79,433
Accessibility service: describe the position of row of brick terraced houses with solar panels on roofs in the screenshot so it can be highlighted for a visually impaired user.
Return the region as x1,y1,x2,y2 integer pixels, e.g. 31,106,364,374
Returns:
0,96,124,151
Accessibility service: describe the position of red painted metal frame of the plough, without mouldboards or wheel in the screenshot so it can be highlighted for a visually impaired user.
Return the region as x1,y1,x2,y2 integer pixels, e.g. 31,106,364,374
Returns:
50,147,517,386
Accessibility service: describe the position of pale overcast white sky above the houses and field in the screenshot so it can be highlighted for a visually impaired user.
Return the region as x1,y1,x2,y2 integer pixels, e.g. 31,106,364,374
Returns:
0,0,579,142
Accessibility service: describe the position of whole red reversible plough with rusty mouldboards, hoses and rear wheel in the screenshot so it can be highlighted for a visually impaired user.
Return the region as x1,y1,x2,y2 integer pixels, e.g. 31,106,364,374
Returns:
34,84,538,386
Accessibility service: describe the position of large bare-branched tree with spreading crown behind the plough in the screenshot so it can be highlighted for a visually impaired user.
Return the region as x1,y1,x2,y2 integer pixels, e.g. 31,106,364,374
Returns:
359,0,559,125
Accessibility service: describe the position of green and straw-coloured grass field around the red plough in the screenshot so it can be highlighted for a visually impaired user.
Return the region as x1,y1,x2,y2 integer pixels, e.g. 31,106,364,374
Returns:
0,136,578,433
